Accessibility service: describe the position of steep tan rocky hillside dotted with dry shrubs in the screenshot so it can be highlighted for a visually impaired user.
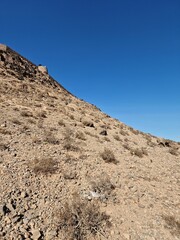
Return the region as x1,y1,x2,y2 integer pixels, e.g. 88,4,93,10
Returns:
0,45,180,240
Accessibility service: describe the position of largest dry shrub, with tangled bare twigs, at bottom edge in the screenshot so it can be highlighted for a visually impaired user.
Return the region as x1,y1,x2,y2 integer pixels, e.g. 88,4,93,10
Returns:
55,196,111,240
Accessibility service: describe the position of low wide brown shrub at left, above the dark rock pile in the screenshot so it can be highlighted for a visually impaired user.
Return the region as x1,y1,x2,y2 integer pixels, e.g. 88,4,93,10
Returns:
31,158,57,174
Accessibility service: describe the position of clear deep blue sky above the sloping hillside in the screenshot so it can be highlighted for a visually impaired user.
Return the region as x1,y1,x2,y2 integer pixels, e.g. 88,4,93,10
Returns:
0,0,180,141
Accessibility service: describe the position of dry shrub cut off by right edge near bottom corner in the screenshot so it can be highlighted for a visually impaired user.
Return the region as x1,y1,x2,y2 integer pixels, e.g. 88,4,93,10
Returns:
163,216,180,237
